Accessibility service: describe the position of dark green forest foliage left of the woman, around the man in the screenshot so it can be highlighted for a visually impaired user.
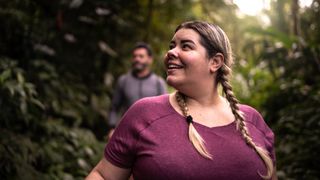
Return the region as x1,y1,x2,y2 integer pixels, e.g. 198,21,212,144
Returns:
0,0,198,179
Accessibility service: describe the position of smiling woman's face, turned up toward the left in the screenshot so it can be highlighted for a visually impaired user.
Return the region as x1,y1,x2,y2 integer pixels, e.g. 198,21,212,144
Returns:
164,29,212,88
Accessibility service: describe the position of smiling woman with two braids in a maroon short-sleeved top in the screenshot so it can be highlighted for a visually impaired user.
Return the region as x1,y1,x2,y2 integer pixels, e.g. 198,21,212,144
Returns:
87,21,276,180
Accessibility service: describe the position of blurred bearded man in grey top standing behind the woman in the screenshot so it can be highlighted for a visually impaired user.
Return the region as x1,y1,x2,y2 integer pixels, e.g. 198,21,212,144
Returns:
108,42,167,138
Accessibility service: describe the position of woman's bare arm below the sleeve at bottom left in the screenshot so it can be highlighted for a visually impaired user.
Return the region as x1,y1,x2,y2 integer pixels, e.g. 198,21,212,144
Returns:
86,158,131,180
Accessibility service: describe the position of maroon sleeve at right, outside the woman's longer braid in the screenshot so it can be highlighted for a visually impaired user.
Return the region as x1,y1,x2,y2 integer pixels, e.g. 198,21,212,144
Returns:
254,111,276,165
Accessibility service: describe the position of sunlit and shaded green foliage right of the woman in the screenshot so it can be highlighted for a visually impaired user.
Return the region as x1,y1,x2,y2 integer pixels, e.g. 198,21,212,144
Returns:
235,1,320,179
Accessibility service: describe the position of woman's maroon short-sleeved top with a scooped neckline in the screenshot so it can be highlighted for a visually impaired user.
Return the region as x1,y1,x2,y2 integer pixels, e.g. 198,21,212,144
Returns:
104,95,275,180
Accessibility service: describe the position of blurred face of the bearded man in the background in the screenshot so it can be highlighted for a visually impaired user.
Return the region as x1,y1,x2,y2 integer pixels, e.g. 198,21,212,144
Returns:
131,48,152,72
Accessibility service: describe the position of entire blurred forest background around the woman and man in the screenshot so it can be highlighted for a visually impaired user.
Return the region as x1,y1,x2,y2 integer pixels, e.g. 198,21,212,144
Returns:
0,0,320,180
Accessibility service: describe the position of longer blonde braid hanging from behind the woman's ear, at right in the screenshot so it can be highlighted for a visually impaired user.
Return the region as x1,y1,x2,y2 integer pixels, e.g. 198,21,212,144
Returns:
217,64,273,179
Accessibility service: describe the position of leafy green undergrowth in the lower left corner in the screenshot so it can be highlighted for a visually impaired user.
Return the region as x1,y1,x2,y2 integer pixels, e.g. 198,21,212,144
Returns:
0,58,103,179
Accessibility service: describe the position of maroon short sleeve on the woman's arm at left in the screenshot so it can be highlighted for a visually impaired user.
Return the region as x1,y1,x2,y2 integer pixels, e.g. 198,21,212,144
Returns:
104,100,142,168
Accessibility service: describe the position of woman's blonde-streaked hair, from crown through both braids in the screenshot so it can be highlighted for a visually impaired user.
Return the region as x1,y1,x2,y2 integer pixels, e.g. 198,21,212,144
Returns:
175,21,274,179
